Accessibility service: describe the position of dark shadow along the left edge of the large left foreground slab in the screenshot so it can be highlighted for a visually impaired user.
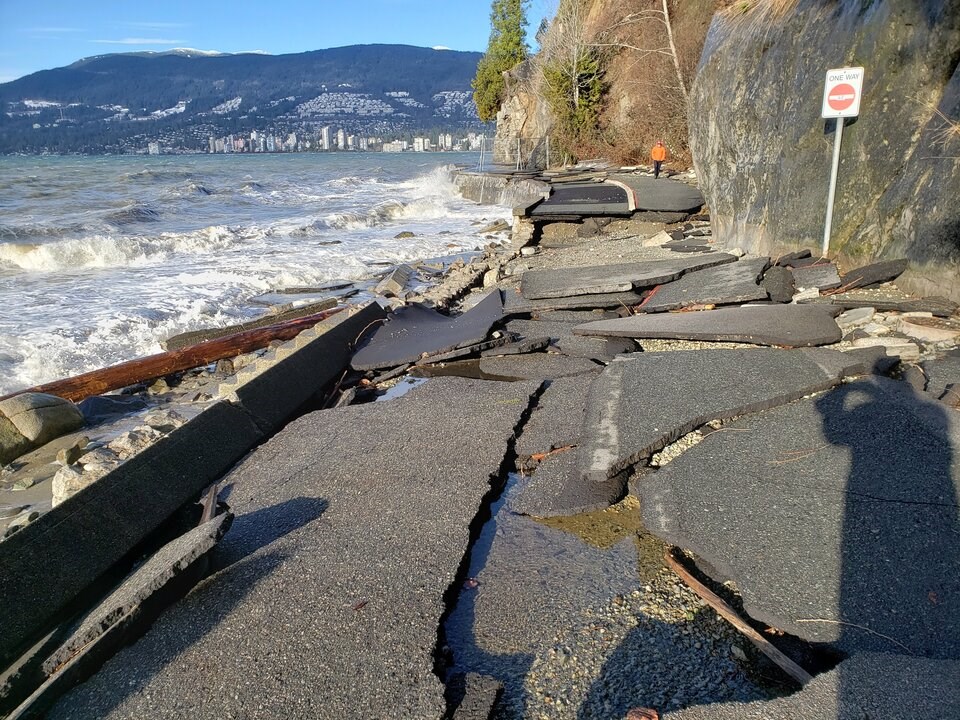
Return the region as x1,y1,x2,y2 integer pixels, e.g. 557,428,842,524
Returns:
46,497,328,720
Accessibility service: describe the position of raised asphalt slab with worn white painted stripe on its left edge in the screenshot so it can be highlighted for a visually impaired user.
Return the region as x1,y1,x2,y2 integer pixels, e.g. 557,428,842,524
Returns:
579,348,867,482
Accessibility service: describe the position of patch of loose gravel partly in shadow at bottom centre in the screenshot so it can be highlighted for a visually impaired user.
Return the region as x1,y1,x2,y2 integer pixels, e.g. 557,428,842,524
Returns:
525,570,771,720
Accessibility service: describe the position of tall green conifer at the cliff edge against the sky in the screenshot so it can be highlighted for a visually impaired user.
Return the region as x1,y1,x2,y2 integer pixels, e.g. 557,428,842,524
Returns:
471,0,528,122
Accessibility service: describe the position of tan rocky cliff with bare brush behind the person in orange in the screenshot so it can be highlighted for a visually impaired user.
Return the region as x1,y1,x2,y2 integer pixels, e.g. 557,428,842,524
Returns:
494,0,723,168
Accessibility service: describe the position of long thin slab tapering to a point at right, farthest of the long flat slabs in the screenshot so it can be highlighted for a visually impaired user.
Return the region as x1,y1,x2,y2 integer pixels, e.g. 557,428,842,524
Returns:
520,253,737,300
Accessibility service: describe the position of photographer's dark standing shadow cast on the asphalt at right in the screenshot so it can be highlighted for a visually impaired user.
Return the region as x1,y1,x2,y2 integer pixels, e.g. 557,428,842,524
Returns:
813,378,960,717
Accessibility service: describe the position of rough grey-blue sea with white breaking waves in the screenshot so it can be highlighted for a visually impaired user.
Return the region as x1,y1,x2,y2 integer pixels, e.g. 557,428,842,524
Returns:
0,153,496,394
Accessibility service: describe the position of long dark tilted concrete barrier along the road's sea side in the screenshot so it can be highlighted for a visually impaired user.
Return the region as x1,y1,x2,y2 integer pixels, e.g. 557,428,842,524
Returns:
0,304,383,667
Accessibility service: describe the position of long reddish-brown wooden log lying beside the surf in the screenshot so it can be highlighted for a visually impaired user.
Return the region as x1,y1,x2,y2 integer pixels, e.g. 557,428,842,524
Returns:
0,308,343,402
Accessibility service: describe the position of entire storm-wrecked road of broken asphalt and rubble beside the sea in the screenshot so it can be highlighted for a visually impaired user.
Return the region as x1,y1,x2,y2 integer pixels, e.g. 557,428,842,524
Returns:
0,160,960,718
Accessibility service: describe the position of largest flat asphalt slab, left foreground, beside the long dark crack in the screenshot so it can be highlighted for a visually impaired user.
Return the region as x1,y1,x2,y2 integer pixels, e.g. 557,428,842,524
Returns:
49,378,540,720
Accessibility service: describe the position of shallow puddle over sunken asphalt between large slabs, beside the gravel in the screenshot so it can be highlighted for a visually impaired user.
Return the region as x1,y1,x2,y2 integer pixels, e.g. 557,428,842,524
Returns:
444,474,640,716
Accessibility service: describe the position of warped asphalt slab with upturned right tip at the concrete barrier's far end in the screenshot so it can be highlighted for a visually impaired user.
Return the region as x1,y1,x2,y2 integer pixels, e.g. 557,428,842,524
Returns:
350,290,503,370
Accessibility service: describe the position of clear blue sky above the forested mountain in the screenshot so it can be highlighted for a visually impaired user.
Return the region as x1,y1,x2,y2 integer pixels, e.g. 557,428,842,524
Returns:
0,0,556,82
